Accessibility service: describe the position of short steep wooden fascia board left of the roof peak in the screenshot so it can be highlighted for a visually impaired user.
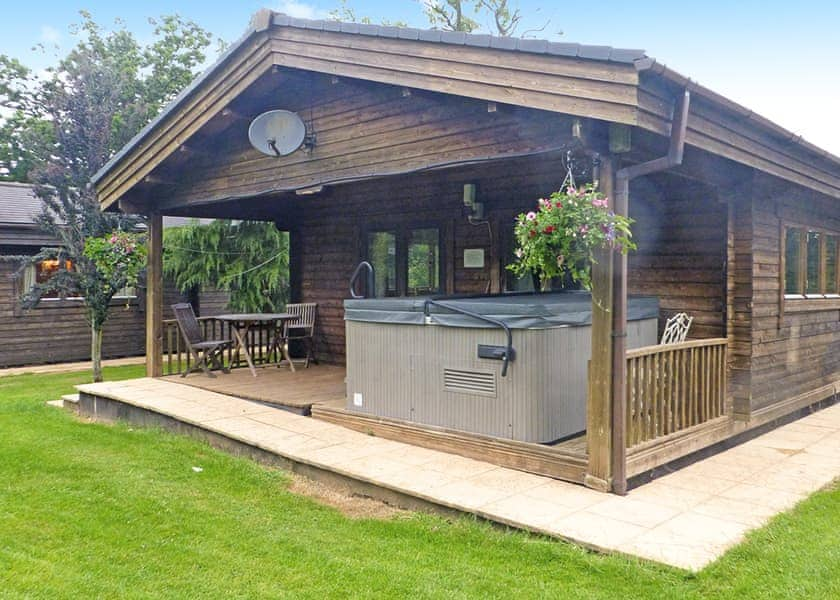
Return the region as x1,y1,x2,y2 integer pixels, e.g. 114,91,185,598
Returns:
96,33,273,210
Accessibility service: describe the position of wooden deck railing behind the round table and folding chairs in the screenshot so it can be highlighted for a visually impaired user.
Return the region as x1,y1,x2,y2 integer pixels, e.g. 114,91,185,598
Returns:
163,317,277,375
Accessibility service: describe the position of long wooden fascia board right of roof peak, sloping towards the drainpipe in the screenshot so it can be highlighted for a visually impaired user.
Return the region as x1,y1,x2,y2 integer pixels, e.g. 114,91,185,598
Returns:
272,28,638,125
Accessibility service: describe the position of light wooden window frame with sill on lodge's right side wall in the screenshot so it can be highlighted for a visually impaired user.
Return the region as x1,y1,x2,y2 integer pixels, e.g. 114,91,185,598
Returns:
779,221,840,313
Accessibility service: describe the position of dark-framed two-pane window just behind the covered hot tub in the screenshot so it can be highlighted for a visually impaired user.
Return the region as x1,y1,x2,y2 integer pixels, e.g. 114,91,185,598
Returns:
366,227,442,298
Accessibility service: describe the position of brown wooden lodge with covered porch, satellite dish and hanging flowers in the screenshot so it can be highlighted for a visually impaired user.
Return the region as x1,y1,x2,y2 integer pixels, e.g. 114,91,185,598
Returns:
94,11,840,493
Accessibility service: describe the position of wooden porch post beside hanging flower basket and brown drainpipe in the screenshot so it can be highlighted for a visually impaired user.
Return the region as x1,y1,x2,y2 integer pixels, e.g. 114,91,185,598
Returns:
584,158,616,492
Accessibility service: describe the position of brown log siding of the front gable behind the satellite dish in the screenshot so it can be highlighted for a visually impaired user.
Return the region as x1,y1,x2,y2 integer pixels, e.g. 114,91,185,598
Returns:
164,79,584,207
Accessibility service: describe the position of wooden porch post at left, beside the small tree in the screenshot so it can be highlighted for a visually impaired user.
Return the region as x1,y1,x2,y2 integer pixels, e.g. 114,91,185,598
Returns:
146,213,163,377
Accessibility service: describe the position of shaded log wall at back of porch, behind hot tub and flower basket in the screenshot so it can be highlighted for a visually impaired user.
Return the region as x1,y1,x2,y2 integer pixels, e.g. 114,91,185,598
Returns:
288,157,727,363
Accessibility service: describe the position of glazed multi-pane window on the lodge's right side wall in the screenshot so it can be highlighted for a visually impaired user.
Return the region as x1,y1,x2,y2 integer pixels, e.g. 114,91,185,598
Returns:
784,227,840,297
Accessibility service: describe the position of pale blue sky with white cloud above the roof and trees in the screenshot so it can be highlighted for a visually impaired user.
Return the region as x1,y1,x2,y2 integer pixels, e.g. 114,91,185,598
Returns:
0,0,840,155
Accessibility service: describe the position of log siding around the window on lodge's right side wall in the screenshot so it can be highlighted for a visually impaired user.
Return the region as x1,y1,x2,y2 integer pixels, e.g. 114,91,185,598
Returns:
750,177,840,410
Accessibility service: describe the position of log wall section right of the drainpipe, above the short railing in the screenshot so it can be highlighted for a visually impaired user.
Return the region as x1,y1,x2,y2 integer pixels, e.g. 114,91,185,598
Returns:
628,177,727,338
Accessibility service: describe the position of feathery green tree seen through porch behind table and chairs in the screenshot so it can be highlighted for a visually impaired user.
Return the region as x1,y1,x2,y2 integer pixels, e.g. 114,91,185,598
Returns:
163,220,289,312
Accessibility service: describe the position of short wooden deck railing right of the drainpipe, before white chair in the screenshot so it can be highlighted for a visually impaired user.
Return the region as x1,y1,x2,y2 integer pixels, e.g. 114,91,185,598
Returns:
626,338,726,448
